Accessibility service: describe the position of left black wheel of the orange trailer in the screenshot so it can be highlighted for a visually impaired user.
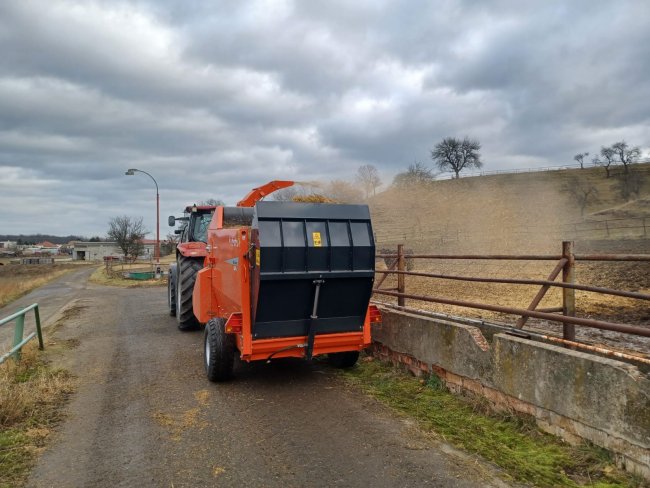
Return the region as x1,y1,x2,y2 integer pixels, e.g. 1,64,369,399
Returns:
203,319,235,381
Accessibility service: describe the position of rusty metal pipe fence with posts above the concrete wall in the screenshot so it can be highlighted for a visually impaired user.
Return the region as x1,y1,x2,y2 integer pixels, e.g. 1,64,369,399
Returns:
373,241,650,341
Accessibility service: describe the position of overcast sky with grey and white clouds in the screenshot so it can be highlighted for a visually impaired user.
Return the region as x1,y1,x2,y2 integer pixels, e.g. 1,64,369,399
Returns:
0,0,650,235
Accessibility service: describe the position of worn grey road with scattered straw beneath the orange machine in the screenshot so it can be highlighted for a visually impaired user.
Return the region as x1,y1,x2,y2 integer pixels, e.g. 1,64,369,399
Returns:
24,276,504,487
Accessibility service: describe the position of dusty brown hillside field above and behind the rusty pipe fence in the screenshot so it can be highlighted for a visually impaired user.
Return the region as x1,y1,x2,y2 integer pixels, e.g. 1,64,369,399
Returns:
370,163,650,354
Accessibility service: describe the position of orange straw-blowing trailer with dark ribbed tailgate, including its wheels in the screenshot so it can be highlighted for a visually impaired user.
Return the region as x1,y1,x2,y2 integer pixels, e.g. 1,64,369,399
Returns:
187,181,381,381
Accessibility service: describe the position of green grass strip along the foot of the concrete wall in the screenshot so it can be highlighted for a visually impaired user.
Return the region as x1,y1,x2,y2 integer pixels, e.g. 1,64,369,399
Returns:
343,358,647,488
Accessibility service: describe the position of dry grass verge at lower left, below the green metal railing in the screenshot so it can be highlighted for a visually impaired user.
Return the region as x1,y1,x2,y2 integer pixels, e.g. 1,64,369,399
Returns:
0,342,74,488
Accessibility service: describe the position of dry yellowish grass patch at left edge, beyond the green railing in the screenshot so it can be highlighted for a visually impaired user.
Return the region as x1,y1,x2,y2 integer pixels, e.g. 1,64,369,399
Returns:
0,264,79,307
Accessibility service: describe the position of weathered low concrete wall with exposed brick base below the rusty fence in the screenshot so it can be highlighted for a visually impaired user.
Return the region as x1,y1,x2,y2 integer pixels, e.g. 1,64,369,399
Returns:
373,310,650,478
